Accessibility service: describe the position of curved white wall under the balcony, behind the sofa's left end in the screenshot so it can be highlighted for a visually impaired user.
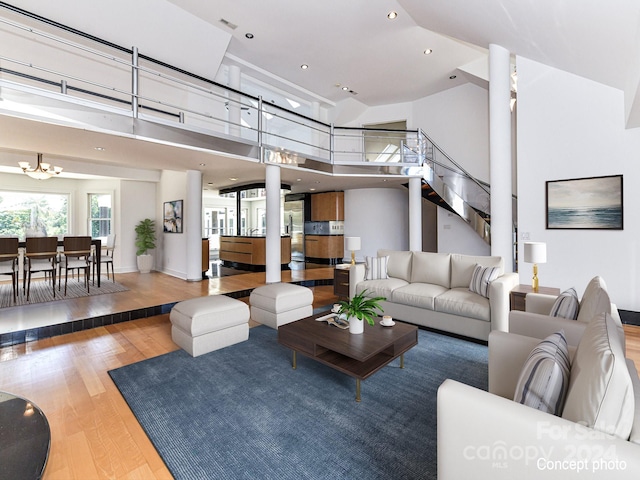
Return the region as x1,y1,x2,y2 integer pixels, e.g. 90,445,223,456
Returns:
344,188,409,262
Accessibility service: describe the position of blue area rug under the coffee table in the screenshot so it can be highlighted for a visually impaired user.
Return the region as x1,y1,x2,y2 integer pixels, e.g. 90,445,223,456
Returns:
109,326,487,480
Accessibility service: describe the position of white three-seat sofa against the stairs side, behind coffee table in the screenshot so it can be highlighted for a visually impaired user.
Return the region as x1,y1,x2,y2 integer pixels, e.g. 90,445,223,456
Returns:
349,250,518,341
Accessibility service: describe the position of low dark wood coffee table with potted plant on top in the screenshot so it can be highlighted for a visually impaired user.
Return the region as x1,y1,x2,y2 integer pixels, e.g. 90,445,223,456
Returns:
278,314,418,402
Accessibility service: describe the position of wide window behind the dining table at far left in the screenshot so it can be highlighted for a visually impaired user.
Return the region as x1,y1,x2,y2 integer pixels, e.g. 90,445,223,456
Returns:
0,191,69,239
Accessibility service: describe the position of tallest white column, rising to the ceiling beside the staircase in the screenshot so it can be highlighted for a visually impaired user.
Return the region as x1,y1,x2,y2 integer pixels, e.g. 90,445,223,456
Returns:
489,44,513,272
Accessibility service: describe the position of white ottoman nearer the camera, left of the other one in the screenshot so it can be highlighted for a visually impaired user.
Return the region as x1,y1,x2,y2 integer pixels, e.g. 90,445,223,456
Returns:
169,295,249,357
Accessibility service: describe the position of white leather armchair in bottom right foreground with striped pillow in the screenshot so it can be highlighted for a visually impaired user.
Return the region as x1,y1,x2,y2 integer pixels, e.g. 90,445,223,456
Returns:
437,313,640,480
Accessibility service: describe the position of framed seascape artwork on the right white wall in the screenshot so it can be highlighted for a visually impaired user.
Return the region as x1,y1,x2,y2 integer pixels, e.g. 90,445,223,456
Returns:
546,175,624,230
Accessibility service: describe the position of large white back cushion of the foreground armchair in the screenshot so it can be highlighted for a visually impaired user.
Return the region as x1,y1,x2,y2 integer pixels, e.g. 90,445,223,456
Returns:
562,313,635,440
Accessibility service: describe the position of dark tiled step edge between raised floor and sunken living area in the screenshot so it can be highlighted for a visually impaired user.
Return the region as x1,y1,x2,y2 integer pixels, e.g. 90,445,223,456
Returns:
0,279,333,348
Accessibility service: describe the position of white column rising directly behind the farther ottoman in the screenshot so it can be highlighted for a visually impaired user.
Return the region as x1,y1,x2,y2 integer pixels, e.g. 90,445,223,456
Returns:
265,164,282,283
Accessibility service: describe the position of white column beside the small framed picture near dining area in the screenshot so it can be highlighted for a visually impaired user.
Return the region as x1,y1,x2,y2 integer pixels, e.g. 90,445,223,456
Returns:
182,170,202,282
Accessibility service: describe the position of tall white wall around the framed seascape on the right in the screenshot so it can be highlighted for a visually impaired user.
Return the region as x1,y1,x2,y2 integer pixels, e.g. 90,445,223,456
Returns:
517,57,640,311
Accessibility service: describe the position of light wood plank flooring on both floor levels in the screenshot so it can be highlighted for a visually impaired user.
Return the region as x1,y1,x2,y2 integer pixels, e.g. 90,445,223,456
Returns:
0,269,640,480
